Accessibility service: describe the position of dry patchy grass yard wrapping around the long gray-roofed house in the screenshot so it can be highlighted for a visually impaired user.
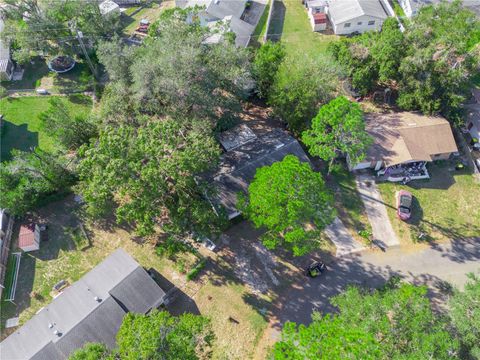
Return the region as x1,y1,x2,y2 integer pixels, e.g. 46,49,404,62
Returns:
1,197,267,359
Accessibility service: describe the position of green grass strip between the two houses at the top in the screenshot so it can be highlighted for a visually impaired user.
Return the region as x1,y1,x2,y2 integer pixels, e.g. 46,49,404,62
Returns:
270,0,337,57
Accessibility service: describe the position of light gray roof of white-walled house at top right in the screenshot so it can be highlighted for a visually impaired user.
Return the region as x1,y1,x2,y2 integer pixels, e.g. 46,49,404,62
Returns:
328,0,388,24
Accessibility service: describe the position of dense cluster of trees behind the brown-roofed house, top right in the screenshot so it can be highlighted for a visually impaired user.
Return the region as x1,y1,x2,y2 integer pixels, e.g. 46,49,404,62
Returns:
330,1,480,120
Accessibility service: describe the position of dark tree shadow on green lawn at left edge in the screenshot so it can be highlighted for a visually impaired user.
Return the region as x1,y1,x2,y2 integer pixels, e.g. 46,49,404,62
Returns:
0,119,38,161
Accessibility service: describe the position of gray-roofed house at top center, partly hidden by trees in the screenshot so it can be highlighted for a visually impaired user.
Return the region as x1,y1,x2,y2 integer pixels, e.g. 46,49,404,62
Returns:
175,0,267,47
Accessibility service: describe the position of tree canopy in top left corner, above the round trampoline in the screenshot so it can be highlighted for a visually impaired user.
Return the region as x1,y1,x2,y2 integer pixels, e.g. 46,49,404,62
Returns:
1,0,120,63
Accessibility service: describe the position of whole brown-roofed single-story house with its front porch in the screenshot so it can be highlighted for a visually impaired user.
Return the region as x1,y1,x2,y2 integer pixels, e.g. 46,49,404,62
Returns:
350,112,458,181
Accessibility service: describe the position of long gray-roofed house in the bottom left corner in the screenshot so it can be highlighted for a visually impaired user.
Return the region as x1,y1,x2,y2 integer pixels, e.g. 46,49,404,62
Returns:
0,249,165,360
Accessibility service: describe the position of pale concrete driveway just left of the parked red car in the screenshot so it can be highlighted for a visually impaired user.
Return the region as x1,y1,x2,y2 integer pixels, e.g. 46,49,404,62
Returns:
355,175,400,246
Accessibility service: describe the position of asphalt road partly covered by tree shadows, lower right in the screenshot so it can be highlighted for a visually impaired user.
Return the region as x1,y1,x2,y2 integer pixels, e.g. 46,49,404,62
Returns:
271,238,480,329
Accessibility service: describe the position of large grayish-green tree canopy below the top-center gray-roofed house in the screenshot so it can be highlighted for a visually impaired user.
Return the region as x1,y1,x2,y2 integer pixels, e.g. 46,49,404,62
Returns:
98,16,252,127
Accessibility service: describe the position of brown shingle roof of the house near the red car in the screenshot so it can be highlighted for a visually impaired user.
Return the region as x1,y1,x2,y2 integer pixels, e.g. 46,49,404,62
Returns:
366,112,458,166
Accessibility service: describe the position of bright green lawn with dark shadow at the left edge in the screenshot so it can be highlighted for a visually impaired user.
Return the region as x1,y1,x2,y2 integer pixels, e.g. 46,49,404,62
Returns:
0,95,92,161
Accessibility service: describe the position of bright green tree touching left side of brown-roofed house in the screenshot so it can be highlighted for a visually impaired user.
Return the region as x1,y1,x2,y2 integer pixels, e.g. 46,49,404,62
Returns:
302,96,372,170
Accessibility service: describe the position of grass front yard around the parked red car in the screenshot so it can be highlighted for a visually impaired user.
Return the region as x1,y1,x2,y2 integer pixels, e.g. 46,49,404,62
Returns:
378,162,480,244
